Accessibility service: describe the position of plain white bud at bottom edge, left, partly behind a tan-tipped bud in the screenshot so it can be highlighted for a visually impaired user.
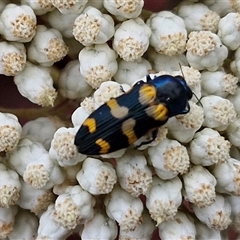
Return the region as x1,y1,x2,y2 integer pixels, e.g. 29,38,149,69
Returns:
36,204,71,240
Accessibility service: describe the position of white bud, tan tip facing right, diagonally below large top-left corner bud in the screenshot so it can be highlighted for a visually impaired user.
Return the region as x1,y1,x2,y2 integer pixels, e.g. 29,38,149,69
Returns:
27,25,68,67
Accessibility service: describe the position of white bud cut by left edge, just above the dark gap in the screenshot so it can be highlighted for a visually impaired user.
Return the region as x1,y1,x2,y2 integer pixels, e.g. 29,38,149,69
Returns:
0,41,26,76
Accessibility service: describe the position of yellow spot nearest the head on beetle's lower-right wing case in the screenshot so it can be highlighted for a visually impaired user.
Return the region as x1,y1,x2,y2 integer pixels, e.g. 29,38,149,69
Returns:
146,104,168,121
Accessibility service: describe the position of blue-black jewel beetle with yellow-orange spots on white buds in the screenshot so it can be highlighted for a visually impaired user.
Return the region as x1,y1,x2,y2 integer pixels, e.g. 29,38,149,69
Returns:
74,75,193,155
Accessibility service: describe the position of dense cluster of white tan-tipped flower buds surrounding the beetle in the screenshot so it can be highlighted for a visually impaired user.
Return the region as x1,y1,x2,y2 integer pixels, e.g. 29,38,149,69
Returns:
0,0,240,240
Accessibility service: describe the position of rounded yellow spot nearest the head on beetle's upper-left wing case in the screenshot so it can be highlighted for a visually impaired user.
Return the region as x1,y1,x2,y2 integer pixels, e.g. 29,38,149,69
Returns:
138,84,157,105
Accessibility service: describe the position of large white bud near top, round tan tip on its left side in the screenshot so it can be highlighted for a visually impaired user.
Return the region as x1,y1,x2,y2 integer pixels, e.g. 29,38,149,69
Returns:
73,6,115,46
